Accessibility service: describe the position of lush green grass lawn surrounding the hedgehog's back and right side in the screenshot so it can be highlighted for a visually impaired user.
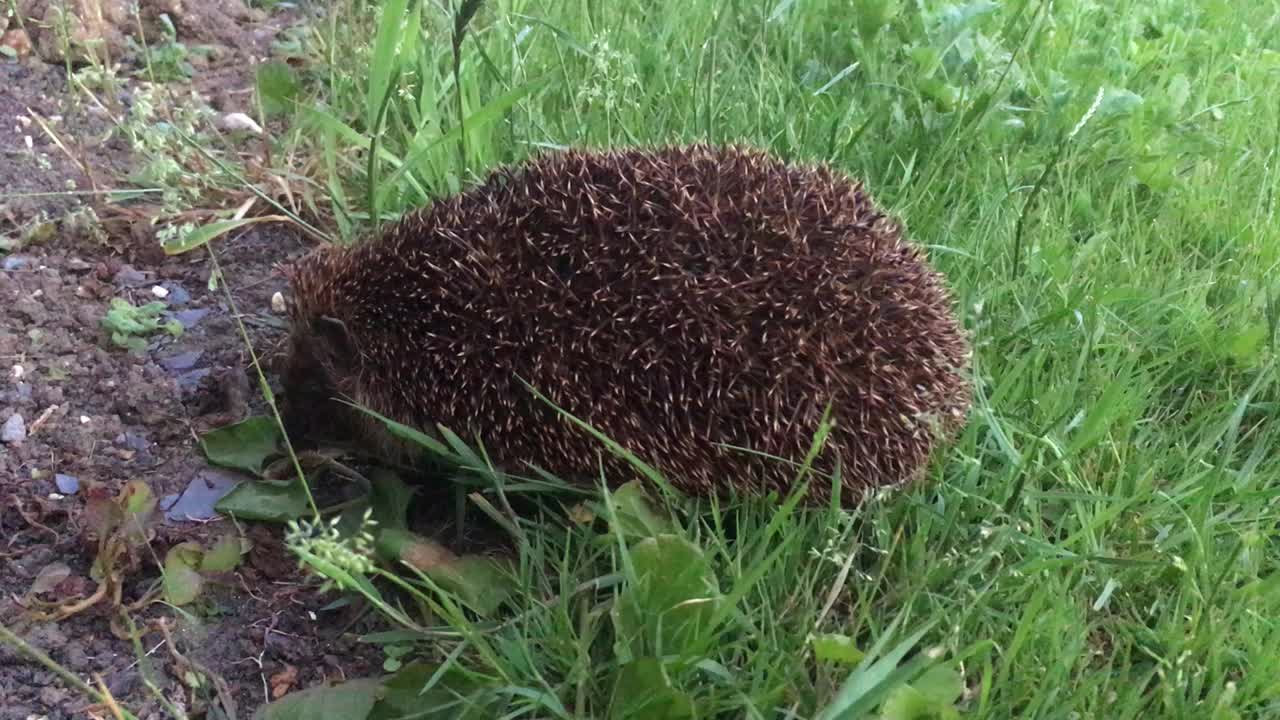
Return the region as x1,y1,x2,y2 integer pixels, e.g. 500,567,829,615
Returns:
252,0,1280,719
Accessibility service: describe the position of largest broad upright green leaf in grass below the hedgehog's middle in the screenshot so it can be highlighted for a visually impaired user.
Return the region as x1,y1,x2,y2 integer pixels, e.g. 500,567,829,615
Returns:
611,534,724,661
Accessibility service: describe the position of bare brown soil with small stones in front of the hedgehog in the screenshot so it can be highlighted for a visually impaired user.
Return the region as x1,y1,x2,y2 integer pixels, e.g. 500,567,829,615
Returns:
0,7,389,720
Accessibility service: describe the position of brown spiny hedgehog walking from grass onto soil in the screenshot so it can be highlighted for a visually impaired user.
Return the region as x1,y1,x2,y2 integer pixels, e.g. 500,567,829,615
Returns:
282,145,970,503
